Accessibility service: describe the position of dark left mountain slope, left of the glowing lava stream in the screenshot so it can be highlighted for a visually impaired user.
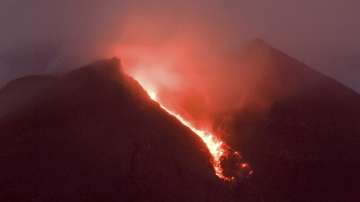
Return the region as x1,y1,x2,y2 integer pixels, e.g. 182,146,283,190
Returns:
0,59,231,201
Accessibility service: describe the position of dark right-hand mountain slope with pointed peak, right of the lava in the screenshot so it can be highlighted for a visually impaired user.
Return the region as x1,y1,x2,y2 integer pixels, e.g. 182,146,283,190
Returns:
225,40,360,201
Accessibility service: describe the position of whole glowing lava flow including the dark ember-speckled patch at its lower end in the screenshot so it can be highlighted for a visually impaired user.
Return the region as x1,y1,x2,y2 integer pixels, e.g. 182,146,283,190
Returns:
134,81,253,181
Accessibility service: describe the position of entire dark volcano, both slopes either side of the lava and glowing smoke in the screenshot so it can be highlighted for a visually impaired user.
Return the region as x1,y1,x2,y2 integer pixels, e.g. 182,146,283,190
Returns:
0,40,360,202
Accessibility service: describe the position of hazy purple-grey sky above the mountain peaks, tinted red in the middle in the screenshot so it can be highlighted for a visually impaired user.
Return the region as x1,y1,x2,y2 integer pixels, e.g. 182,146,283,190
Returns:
0,0,360,92
